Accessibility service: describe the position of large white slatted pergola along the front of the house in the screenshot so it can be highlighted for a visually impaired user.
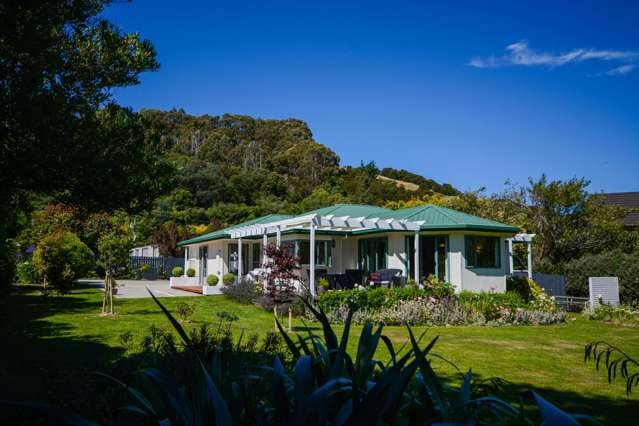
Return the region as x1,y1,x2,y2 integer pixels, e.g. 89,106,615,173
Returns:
230,214,424,296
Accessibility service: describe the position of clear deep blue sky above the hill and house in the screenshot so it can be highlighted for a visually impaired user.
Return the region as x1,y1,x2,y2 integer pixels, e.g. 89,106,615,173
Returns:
105,0,639,192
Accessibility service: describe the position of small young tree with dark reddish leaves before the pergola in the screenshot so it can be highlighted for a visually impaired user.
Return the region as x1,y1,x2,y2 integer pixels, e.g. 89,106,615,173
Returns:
264,244,300,332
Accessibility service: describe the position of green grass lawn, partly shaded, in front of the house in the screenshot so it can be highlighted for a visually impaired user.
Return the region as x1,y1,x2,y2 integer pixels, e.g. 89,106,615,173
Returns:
0,286,639,424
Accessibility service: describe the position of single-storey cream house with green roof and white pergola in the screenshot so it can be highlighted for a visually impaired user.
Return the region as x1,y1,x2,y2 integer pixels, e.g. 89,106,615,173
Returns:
178,204,531,293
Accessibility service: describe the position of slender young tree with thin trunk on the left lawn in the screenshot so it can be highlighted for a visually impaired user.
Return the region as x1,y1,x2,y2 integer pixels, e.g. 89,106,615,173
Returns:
98,230,132,315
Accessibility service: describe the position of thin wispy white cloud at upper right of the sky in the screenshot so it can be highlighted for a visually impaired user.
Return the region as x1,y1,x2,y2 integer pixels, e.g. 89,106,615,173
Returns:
467,41,639,75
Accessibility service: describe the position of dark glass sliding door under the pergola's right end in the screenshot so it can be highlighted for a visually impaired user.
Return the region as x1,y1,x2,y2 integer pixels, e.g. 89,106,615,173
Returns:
405,235,448,281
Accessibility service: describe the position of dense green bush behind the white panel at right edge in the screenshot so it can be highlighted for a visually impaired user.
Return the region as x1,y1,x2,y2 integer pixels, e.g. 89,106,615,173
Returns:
563,251,639,303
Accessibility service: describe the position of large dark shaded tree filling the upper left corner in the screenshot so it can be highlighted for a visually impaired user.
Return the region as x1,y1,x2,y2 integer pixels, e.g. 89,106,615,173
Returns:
0,0,167,282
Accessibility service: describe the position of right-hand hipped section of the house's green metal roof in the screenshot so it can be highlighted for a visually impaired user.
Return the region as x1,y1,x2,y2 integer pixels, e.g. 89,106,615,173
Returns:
379,204,519,233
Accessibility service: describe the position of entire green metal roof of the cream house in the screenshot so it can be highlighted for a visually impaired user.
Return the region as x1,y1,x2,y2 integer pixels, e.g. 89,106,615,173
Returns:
178,204,519,246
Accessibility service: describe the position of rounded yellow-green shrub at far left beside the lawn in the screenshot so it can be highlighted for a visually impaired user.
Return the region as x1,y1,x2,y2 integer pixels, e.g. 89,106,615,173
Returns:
33,231,95,293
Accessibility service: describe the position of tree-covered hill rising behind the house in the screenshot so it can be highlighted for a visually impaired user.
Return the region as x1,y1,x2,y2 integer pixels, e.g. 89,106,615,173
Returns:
141,110,458,231
